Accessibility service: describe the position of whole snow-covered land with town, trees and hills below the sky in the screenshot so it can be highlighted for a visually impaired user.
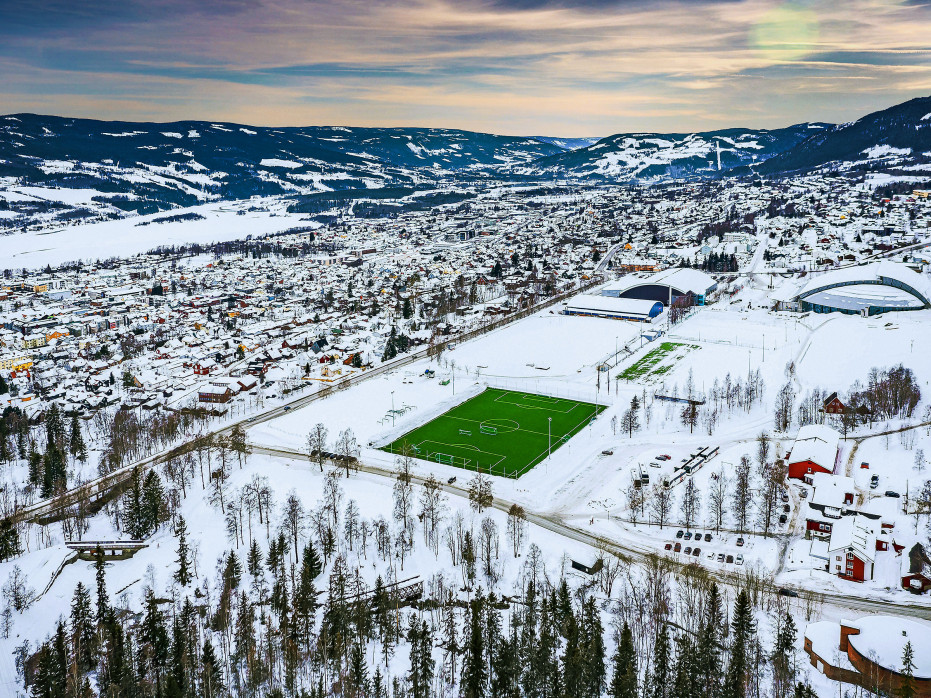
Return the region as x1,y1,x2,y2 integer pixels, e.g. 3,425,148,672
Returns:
0,92,931,698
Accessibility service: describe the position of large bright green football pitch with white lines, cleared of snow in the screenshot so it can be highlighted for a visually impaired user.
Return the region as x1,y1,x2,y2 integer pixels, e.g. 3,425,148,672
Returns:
382,388,605,478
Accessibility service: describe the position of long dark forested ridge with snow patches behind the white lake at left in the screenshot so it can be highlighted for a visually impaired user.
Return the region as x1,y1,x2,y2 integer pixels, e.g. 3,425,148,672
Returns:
0,114,565,212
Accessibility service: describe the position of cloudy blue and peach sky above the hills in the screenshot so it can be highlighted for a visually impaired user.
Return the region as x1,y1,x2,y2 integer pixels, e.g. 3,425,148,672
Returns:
0,0,931,136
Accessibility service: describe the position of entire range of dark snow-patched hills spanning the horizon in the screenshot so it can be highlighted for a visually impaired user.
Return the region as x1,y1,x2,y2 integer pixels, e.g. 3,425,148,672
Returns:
0,97,931,232
